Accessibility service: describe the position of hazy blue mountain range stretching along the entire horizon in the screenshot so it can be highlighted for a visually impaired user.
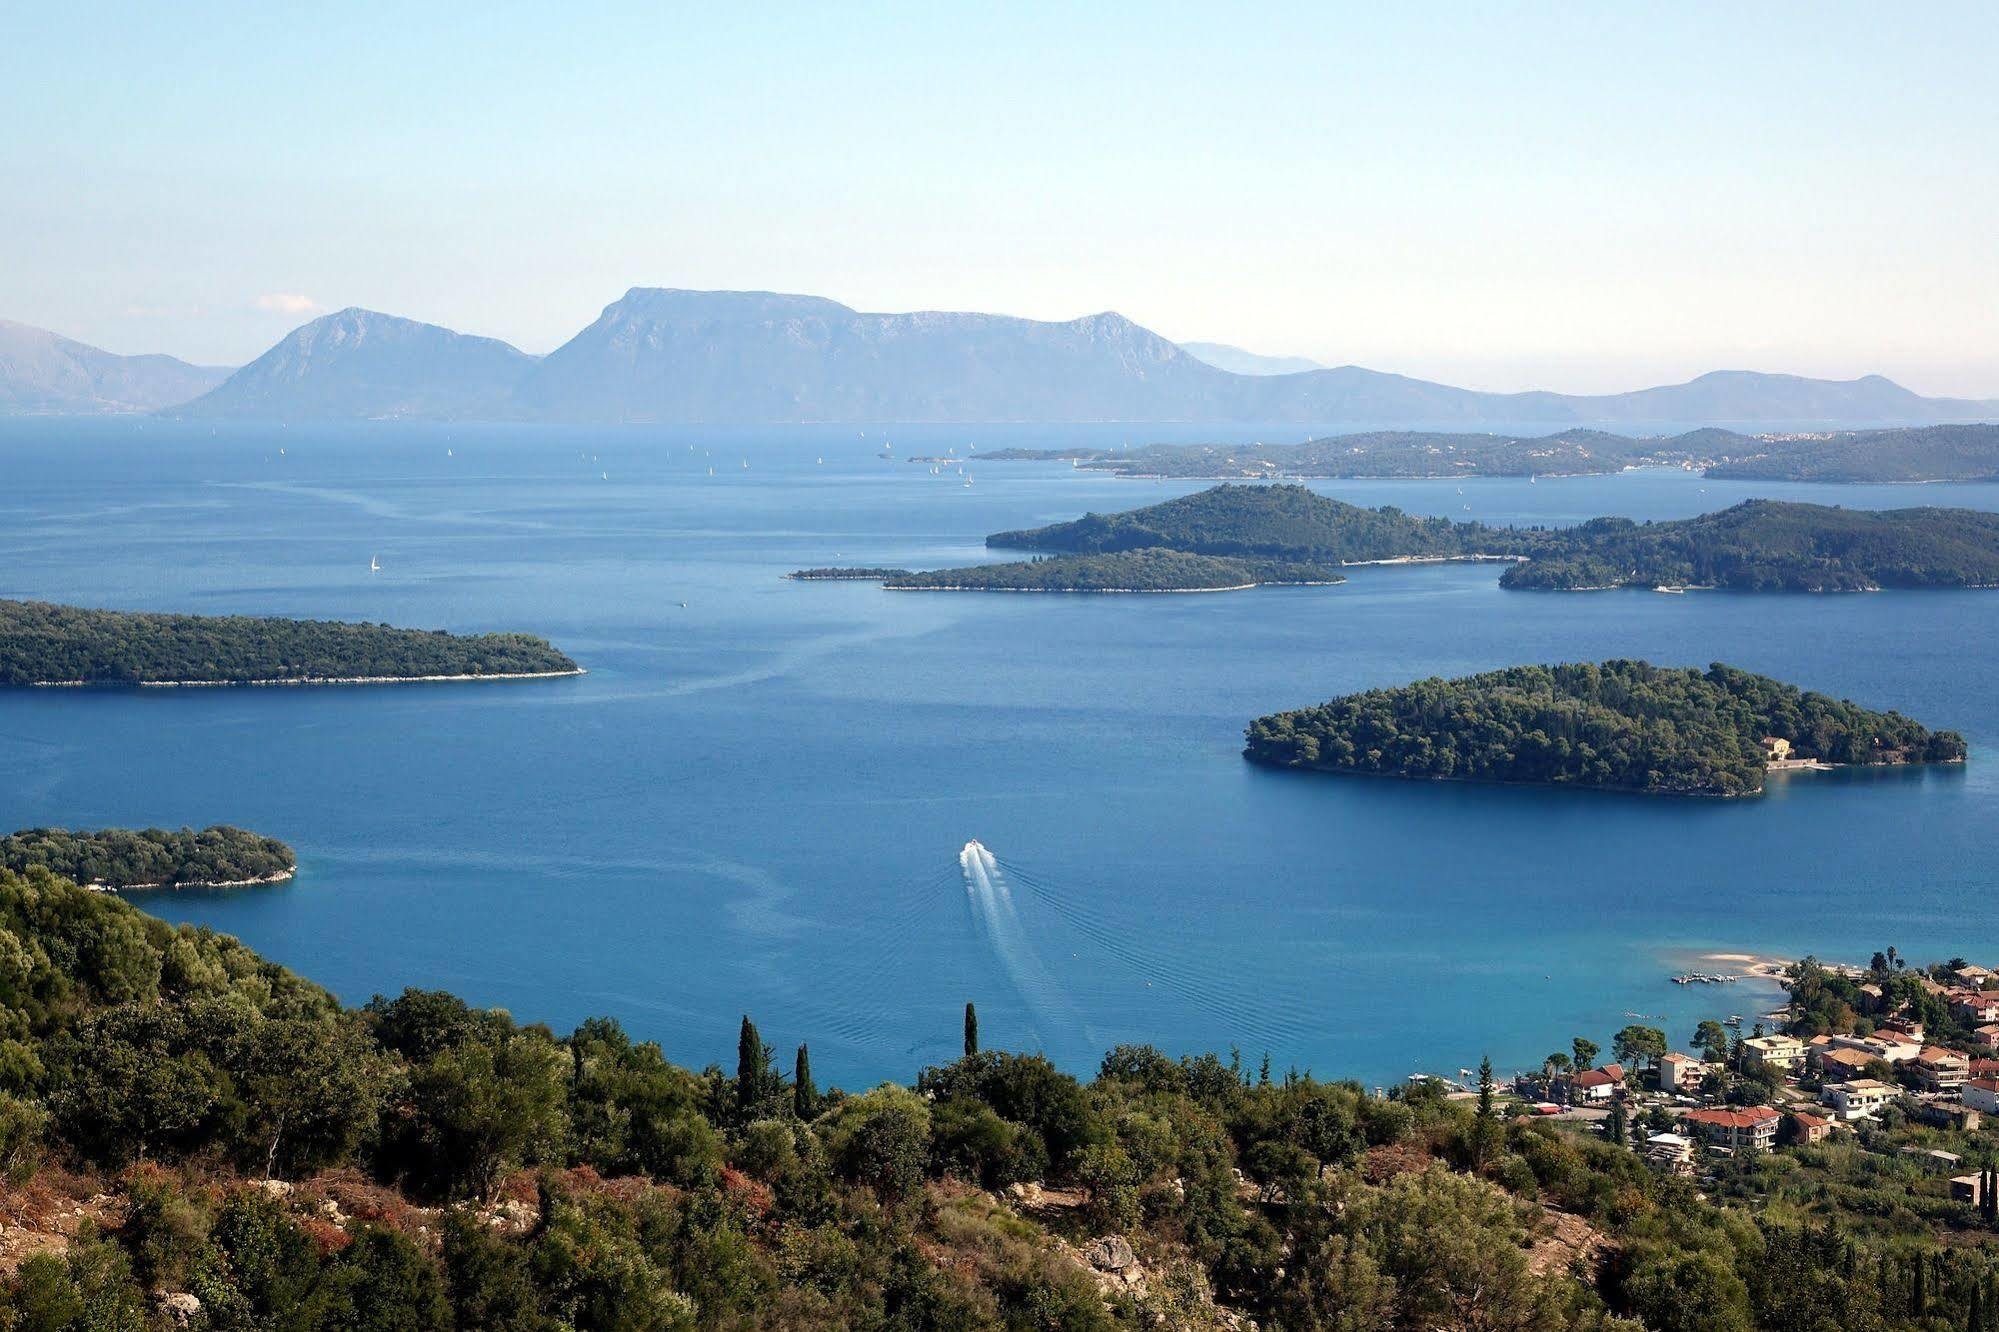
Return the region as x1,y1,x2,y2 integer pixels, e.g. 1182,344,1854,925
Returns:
0,288,1999,428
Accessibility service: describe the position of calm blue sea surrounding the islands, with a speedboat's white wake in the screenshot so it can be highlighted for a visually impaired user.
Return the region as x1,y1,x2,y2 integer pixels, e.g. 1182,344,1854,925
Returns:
0,422,1999,1086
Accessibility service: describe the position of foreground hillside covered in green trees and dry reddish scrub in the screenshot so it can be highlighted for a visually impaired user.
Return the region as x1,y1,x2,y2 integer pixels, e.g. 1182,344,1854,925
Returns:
0,868,1999,1332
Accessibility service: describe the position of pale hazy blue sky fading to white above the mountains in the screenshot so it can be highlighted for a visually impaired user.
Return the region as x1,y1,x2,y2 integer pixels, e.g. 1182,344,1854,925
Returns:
0,0,1999,396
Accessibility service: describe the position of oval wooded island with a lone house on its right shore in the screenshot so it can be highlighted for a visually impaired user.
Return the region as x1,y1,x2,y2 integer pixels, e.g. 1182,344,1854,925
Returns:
1243,660,1965,796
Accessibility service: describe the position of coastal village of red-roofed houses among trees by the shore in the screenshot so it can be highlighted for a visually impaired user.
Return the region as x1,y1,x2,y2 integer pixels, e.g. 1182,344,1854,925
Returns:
1479,948,1999,1216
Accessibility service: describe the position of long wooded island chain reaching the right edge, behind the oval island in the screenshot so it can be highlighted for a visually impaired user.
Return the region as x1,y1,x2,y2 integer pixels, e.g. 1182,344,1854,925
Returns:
792,484,1999,592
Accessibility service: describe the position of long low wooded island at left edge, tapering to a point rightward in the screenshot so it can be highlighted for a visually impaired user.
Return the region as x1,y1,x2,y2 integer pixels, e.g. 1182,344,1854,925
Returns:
0,600,582,686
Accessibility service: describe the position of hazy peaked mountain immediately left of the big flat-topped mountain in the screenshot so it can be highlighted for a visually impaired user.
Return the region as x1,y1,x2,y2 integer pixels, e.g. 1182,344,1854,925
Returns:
172,308,534,420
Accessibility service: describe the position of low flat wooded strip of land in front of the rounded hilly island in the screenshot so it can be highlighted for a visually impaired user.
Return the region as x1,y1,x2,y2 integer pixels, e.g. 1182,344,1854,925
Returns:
882,548,1345,592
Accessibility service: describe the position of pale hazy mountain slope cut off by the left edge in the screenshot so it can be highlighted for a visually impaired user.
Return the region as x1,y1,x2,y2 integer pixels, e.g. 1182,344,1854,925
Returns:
0,320,228,416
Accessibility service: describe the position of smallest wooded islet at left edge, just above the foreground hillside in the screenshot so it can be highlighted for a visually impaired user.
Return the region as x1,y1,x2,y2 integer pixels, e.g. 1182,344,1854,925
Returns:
0,824,298,888
